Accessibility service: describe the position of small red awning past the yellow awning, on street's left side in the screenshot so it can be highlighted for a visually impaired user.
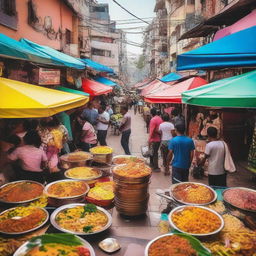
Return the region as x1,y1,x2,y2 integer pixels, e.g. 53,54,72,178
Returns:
82,79,113,96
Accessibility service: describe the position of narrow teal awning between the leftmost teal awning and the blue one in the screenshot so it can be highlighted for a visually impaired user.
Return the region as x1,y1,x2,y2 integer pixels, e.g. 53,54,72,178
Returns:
20,38,85,69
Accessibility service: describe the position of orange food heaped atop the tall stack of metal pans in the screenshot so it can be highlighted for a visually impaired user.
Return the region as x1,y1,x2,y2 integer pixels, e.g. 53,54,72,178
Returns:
113,163,151,178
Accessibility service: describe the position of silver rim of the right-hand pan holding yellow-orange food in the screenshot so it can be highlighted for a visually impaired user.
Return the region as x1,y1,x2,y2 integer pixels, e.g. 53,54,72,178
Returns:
168,205,224,237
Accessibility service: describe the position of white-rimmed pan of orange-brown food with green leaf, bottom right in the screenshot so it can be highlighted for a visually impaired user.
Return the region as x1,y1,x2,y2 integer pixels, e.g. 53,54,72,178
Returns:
144,233,211,256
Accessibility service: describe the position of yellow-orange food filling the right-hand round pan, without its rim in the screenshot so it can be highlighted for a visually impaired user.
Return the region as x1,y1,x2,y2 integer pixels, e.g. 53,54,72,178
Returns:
171,206,221,234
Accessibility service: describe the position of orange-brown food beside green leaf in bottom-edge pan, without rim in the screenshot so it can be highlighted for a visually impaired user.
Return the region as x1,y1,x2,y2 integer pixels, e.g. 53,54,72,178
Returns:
148,235,198,256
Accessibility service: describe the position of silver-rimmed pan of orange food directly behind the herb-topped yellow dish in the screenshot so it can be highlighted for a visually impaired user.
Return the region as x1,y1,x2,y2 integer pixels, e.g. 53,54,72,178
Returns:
44,180,90,199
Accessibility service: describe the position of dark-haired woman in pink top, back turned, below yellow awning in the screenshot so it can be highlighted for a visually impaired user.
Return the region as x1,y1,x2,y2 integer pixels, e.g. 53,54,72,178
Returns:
8,131,47,183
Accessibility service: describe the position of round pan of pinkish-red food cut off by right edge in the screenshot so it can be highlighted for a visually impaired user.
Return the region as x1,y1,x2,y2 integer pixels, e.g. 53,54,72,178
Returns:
222,187,256,212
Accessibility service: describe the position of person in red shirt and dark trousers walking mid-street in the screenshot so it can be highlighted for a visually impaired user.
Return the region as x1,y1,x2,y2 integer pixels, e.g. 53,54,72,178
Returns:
148,108,163,172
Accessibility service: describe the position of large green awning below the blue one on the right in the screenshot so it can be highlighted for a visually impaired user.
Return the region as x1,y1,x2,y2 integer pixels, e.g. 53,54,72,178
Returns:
182,71,256,108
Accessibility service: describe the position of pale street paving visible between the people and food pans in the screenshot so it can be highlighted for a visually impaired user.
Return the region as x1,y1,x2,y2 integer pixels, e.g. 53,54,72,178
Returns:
102,111,255,256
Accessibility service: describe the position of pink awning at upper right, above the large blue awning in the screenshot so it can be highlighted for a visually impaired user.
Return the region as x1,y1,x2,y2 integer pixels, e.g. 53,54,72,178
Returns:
213,9,256,41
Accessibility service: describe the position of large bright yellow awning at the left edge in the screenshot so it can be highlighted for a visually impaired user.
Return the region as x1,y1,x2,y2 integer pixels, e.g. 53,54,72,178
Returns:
0,78,89,118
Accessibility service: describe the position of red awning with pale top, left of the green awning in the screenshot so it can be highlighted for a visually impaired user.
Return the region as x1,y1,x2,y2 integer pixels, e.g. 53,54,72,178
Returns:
144,77,207,103
